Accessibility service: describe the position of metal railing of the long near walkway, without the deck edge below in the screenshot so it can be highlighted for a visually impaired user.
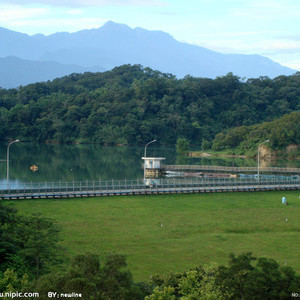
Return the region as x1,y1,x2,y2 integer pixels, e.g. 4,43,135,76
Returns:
0,176,300,196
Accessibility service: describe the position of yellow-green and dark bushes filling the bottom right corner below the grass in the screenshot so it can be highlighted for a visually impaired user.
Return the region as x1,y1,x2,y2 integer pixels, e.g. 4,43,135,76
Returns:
146,253,300,300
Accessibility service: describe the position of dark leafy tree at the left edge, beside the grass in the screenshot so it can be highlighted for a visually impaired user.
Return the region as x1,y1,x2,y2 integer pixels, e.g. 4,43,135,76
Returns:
0,204,61,283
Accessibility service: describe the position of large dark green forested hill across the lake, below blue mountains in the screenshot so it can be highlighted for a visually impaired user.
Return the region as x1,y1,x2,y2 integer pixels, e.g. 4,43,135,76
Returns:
0,65,300,144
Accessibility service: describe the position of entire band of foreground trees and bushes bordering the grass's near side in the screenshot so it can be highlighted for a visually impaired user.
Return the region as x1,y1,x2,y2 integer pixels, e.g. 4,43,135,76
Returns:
0,204,300,300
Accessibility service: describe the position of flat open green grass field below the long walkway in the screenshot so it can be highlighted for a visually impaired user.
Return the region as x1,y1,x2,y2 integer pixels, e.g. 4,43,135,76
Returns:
5,191,300,281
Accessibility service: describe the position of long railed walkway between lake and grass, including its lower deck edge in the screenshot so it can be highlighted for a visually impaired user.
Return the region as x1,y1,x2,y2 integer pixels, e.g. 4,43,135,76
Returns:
0,176,300,199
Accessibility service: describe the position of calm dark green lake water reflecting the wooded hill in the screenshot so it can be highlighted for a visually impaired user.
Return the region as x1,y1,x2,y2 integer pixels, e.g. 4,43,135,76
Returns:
0,142,300,183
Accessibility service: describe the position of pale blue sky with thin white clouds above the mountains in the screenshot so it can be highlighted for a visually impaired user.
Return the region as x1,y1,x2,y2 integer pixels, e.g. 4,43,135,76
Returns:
0,0,300,70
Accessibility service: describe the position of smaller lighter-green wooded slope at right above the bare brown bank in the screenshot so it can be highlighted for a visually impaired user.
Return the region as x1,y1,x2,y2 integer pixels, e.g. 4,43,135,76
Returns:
212,111,300,154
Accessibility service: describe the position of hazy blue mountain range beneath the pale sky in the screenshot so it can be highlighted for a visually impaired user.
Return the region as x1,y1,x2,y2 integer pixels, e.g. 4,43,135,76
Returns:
0,21,296,88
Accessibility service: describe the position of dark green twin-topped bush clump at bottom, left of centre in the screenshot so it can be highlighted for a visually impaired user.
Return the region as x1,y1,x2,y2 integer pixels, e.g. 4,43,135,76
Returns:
32,253,148,300
